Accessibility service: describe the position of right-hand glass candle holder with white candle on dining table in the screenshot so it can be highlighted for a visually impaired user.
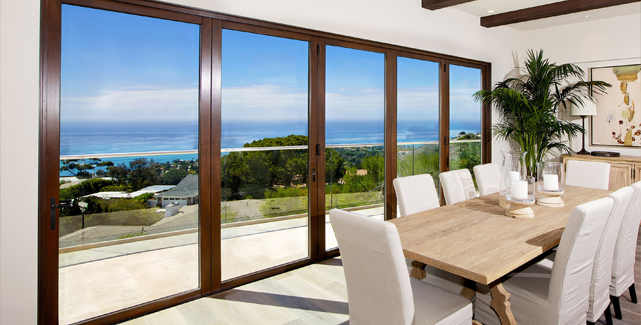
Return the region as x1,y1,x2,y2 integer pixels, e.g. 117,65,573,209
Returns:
536,162,565,208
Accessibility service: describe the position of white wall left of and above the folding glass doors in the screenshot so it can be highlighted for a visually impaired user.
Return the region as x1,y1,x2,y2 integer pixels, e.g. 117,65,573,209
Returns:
0,0,522,324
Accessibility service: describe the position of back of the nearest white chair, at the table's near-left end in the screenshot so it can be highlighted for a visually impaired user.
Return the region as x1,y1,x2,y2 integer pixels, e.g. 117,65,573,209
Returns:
329,209,414,325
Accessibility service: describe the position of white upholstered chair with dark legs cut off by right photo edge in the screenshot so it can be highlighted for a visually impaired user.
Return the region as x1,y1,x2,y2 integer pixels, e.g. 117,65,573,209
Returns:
610,182,641,319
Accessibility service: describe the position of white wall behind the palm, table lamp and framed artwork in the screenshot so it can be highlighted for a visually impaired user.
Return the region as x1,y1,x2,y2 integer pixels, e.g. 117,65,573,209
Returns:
523,14,641,156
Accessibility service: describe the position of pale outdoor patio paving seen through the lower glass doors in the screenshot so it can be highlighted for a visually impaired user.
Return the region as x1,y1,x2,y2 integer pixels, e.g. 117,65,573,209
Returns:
60,207,383,324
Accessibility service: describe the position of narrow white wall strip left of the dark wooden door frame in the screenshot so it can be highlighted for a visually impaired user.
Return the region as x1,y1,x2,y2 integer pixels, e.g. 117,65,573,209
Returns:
0,0,40,324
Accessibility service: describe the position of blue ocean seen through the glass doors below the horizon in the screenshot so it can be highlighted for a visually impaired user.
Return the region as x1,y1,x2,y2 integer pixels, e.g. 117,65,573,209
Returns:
60,120,480,173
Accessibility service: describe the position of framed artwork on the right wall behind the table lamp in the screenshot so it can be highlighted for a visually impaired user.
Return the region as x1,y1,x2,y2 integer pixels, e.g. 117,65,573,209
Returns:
590,64,641,148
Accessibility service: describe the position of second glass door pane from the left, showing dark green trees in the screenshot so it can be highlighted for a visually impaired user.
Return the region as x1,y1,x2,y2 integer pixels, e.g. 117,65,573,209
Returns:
221,30,309,280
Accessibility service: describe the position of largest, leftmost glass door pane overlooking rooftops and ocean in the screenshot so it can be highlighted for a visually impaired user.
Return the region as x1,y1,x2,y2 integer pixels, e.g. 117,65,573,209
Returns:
59,5,200,324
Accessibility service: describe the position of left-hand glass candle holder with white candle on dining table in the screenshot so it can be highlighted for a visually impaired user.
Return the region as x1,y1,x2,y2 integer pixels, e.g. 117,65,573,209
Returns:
505,176,536,219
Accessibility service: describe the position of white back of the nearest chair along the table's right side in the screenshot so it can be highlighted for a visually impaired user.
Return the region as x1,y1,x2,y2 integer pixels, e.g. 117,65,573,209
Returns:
548,197,614,324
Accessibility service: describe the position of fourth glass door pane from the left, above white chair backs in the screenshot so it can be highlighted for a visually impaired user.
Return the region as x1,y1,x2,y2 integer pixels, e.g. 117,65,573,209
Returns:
396,57,440,192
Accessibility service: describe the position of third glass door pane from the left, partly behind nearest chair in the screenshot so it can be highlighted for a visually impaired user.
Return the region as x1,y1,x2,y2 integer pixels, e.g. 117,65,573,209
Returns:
325,46,385,250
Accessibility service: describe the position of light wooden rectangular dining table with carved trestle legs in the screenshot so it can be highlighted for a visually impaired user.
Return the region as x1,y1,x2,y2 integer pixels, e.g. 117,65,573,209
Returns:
389,185,612,325
